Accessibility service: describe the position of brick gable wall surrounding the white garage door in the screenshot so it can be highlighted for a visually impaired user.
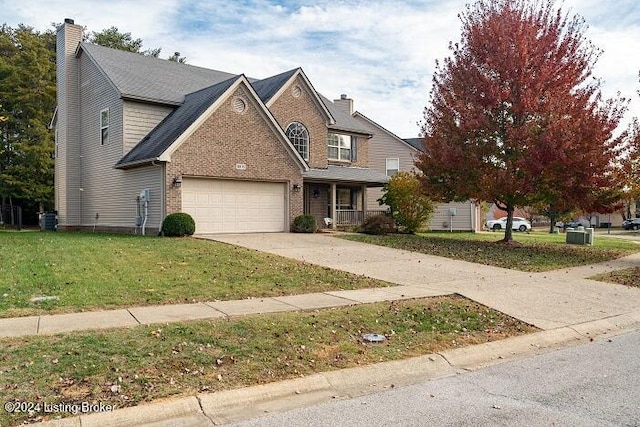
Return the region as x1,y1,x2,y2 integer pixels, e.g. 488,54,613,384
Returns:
165,85,303,231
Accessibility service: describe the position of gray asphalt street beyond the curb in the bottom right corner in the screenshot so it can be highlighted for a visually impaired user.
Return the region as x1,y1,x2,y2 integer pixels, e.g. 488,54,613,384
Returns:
233,332,640,427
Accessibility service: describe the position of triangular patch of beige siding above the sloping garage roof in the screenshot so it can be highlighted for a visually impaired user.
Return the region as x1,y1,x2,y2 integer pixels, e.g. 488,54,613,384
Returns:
122,101,173,156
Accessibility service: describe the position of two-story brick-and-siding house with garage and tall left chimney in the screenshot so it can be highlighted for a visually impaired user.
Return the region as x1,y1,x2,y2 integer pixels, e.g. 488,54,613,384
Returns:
52,19,388,233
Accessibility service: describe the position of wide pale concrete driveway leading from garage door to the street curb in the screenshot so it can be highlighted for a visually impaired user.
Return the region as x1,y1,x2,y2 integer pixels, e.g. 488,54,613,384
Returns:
198,233,640,329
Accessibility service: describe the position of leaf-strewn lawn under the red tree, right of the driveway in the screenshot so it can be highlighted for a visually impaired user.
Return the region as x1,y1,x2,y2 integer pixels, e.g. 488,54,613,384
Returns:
343,232,640,272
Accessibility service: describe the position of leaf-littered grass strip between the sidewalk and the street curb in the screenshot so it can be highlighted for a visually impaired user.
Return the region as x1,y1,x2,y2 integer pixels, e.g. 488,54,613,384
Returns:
0,296,536,425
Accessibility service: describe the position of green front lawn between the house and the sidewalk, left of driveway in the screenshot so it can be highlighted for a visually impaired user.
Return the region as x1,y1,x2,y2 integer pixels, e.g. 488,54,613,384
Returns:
0,231,389,317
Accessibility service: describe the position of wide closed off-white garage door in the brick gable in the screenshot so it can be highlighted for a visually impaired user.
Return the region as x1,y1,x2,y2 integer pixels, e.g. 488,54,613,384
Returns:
182,178,286,233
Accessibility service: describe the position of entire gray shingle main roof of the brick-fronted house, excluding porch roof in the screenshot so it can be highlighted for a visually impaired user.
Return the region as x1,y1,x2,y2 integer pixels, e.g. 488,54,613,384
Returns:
81,43,376,167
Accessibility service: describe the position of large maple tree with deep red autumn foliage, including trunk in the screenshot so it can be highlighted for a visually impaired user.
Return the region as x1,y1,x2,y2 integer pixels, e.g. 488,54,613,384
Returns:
416,0,626,242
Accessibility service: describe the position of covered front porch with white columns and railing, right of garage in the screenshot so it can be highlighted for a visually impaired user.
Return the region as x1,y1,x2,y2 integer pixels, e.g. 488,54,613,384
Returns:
303,166,388,228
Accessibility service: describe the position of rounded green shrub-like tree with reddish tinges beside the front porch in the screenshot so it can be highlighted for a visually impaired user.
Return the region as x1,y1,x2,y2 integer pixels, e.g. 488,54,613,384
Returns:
378,172,433,233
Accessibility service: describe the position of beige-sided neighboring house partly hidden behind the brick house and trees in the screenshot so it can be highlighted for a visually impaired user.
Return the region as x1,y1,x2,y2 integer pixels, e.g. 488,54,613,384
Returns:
350,108,482,231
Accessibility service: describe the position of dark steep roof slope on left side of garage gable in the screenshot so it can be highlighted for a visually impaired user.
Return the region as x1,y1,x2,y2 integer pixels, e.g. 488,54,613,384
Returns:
116,76,240,167
